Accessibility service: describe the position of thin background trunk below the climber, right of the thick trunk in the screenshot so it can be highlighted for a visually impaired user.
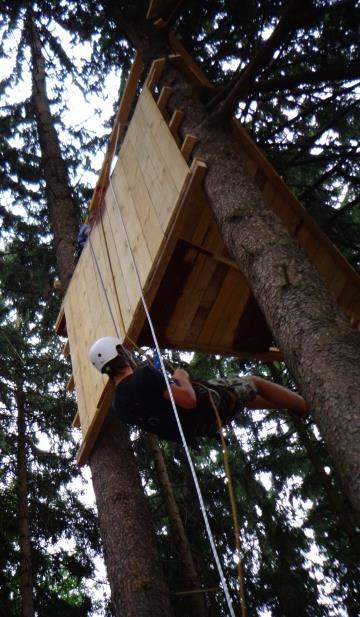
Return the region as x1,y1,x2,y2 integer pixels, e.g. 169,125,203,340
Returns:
146,433,205,617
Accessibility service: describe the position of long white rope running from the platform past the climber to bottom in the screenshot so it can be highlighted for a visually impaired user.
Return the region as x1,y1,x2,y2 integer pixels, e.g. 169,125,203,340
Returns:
104,177,235,617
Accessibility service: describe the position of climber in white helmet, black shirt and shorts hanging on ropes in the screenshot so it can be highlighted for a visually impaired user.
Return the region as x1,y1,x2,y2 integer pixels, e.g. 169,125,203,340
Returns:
89,336,309,443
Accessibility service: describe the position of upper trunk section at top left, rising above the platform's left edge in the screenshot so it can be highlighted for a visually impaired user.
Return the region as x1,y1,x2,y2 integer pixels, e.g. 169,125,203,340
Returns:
28,17,79,292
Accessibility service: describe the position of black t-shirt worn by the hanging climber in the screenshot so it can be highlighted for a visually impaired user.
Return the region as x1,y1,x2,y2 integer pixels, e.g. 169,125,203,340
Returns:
113,366,236,443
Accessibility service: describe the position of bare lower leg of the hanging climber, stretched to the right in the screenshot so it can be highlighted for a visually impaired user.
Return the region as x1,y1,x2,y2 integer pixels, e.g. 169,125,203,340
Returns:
246,375,309,416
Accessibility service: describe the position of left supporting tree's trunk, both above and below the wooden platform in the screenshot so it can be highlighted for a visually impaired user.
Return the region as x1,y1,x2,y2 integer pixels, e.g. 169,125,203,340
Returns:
28,15,172,617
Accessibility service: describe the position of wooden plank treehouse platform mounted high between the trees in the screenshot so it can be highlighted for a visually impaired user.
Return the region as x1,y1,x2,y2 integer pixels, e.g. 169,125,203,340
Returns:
56,39,360,464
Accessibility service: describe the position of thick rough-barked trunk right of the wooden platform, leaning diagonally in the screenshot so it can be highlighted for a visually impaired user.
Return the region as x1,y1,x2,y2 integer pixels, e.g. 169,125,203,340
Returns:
163,70,360,514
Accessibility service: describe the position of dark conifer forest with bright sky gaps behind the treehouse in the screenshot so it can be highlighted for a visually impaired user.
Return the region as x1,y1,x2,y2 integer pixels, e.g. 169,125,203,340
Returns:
0,0,360,617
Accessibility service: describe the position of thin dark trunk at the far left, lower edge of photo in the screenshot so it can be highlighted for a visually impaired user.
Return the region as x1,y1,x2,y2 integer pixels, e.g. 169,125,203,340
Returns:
15,384,35,617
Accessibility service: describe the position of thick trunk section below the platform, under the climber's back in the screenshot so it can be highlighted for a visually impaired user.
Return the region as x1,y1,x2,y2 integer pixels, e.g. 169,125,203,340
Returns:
90,414,172,617
